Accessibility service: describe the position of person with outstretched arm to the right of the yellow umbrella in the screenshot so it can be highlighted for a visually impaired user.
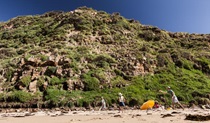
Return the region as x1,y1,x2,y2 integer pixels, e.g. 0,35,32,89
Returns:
159,86,184,110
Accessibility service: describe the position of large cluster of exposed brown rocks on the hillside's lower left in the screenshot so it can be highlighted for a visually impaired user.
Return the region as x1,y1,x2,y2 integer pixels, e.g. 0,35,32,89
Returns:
0,53,88,93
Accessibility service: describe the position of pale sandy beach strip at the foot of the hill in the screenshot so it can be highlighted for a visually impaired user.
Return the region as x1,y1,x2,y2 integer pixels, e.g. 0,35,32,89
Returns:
0,109,210,123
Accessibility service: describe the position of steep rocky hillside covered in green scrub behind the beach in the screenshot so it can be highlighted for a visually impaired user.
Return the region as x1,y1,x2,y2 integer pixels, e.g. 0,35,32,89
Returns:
0,7,210,107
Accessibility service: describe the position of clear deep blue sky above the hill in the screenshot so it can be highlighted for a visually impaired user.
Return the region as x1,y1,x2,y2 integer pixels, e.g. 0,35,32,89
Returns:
0,0,210,34
